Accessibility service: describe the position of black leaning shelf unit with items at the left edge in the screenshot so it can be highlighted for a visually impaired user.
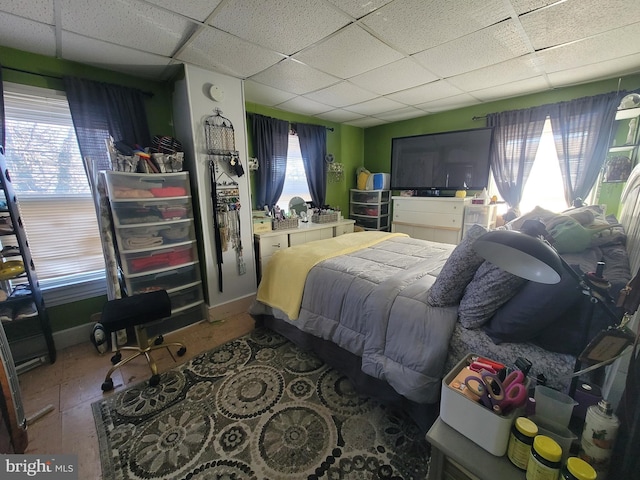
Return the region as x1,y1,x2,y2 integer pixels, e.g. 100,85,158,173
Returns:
0,154,56,366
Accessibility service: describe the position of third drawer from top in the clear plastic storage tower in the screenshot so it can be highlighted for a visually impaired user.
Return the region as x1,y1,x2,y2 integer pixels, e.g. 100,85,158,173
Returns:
116,220,196,251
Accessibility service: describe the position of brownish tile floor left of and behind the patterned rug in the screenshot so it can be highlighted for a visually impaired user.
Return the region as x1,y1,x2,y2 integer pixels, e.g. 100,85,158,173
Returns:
19,314,254,480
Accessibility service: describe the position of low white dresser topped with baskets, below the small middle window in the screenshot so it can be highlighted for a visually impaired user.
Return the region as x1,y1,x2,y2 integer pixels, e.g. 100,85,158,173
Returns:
253,220,355,283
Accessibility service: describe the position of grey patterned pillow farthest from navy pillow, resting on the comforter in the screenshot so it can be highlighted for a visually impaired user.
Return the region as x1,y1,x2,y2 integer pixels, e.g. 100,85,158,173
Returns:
427,225,487,307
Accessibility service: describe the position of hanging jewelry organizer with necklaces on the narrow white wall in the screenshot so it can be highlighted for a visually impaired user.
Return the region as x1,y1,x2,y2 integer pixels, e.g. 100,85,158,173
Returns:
204,108,247,292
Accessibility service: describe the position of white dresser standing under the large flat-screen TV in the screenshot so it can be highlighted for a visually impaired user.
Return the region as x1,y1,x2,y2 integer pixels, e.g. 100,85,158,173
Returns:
391,196,471,245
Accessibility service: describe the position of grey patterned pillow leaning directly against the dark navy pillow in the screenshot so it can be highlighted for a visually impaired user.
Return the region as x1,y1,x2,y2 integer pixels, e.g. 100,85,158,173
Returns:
458,262,527,329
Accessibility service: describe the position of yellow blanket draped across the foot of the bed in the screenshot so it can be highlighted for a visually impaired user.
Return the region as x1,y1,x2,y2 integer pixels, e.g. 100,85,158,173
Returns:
257,231,407,320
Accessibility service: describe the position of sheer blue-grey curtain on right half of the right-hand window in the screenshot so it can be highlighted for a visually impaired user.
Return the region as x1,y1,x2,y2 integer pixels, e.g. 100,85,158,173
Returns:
549,92,626,206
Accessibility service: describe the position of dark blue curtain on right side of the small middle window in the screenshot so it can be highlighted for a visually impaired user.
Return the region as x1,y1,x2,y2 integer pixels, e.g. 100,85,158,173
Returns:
294,123,327,208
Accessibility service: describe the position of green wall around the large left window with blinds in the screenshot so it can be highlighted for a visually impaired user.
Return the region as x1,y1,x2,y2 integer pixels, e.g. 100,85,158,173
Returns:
0,46,173,332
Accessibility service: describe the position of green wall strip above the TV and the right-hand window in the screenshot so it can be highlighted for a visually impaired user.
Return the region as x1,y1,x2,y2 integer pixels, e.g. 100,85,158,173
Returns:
364,75,640,172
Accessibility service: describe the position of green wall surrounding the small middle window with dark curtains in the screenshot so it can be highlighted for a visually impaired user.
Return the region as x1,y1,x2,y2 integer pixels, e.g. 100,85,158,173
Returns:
245,102,364,217
